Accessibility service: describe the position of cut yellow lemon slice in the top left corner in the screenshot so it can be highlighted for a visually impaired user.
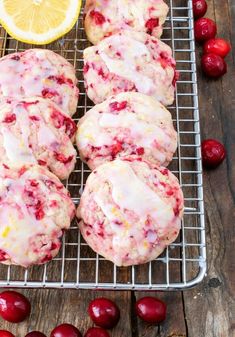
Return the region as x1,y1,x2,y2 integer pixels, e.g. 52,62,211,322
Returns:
0,0,82,45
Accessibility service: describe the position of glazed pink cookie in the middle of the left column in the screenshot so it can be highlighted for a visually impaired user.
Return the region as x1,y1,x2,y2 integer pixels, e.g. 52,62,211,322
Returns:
0,97,76,179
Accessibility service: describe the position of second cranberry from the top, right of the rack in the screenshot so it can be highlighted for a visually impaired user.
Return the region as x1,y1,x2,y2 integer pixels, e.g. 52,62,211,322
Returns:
194,18,217,42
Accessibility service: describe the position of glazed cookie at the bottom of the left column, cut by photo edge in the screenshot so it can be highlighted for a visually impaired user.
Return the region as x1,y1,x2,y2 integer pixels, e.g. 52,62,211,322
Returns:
0,164,75,267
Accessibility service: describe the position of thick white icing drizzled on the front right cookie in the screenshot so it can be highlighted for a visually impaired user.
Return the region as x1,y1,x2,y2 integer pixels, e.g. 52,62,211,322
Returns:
95,160,174,227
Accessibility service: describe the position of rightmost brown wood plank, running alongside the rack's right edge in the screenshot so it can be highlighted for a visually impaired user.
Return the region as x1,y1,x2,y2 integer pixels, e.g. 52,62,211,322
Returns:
184,0,235,337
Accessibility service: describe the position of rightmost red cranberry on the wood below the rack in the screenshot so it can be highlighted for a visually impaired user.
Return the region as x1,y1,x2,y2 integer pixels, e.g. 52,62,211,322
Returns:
135,297,166,323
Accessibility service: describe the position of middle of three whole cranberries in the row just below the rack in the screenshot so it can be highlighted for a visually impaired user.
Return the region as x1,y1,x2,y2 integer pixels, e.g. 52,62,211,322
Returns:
88,298,120,329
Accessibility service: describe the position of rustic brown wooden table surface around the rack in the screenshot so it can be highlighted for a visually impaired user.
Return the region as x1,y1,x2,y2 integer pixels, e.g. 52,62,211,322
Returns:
0,0,235,337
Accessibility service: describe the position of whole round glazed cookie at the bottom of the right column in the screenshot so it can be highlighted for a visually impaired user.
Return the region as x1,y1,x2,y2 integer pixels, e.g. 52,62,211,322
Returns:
77,158,184,266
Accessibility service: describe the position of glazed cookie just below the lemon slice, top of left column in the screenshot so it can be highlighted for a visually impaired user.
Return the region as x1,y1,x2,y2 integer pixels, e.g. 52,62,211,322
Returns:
0,49,79,116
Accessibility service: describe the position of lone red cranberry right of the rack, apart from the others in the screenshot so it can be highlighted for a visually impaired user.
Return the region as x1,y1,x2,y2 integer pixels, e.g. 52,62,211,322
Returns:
202,139,226,168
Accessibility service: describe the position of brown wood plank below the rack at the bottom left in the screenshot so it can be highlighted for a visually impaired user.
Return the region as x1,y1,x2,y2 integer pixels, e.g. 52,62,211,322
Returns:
0,289,131,337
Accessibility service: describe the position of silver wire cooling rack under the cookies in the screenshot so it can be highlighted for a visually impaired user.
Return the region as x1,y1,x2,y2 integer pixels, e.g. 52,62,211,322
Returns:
0,0,206,290
